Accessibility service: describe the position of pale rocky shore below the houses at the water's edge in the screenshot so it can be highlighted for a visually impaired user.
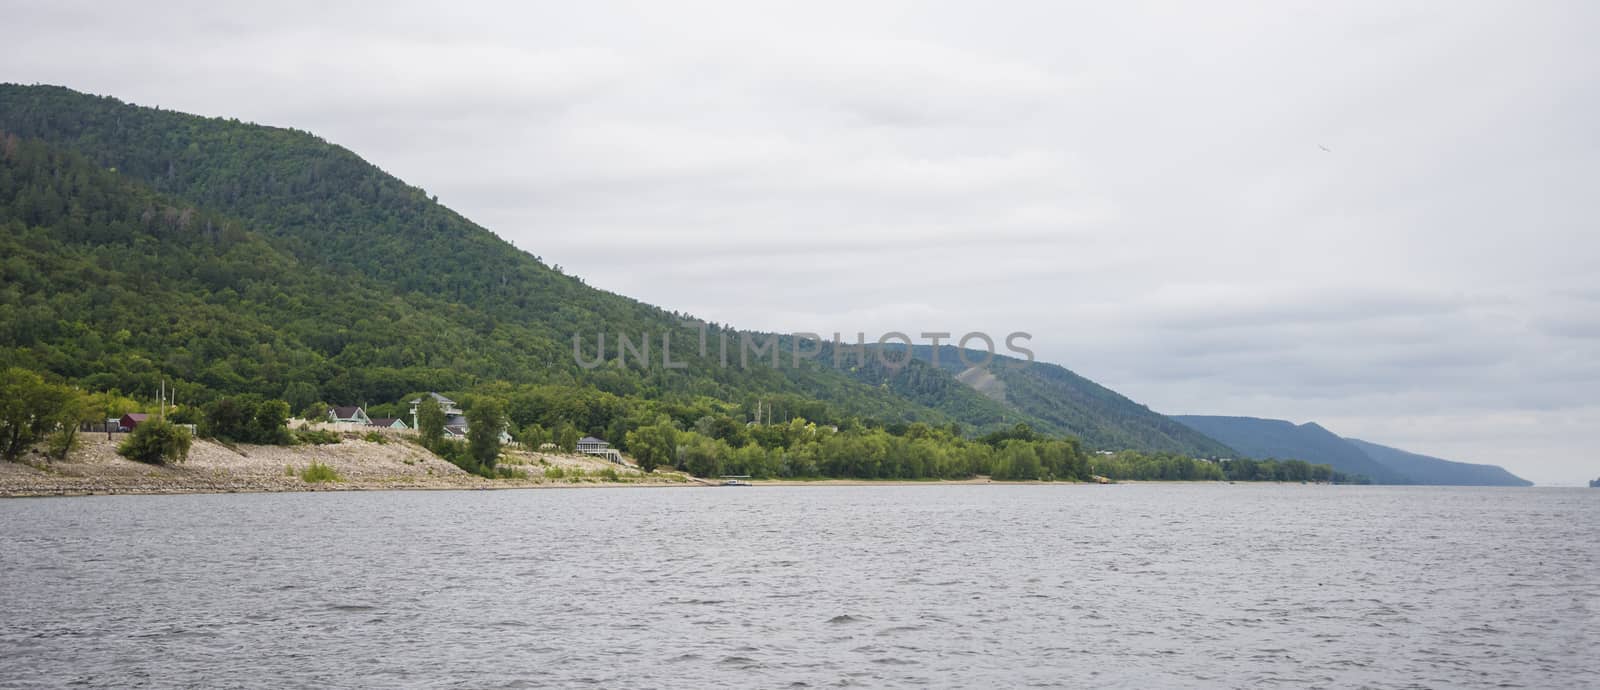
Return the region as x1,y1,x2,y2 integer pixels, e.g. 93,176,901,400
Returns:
0,434,701,496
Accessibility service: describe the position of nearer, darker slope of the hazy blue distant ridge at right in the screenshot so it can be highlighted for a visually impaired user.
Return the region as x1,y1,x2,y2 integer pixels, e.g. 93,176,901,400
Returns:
1173,415,1411,483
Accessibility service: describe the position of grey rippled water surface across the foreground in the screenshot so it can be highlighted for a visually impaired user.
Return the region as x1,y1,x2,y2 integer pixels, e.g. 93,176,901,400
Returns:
0,483,1600,688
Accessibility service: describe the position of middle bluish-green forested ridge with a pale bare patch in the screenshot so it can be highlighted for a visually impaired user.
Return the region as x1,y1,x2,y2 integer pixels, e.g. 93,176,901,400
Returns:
912,346,1235,458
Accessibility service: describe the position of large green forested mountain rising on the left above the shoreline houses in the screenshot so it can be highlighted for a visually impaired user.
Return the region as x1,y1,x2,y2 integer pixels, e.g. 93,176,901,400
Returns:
0,85,1219,455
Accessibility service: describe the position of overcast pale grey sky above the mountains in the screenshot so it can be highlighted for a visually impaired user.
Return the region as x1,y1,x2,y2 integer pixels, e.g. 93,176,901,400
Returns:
0,0,1600,485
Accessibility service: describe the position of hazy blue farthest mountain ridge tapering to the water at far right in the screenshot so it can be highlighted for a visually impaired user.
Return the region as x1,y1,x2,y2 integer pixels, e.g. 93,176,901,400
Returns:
1173,415,1533,487
